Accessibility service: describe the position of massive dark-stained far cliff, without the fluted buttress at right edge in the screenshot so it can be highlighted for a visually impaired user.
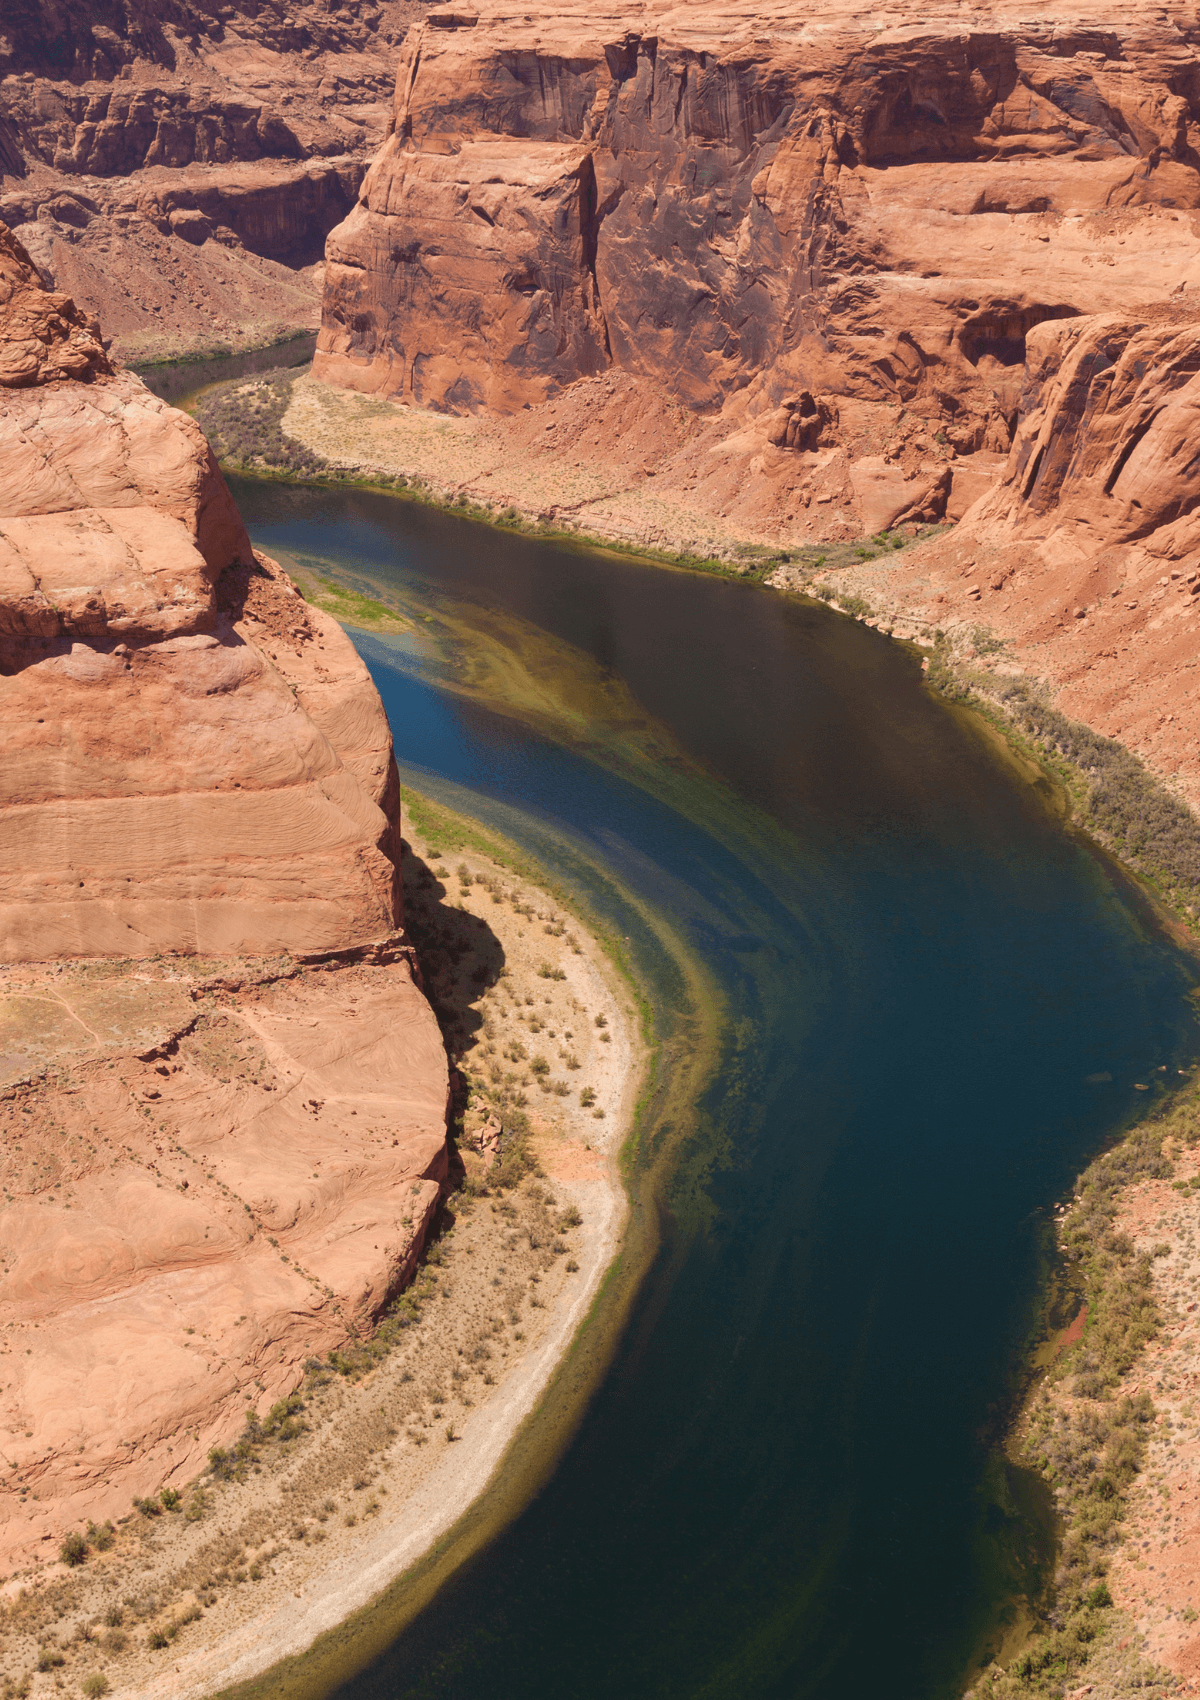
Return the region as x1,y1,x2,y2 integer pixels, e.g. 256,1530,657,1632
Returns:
316,0,1200,542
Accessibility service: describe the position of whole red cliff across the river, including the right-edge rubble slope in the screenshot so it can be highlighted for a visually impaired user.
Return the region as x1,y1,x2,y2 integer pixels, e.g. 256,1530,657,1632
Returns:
314,0,1200,789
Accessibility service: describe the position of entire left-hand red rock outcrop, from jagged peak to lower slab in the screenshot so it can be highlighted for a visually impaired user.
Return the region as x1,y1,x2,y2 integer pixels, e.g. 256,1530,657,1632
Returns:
0,230,447,1564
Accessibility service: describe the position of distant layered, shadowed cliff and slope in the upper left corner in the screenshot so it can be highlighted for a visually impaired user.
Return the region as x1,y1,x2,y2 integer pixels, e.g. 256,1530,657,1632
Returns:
0,0,438,359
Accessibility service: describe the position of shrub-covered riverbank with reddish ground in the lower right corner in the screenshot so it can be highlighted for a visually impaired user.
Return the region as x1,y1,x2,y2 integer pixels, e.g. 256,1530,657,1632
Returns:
971,1071,1200,1700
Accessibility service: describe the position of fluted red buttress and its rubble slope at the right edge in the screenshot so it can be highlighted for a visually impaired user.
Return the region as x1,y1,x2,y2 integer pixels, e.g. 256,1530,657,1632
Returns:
889,308,1200,802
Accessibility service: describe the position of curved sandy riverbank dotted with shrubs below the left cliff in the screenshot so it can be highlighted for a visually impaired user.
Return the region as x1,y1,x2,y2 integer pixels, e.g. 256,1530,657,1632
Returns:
2,799,644,1697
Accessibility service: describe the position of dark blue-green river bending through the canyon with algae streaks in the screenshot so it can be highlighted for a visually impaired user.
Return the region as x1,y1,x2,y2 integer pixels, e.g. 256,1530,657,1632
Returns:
235,481,1197,1700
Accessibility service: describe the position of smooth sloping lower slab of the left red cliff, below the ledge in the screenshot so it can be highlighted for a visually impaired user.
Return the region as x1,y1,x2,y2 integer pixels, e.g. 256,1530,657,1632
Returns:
0,952,447,1571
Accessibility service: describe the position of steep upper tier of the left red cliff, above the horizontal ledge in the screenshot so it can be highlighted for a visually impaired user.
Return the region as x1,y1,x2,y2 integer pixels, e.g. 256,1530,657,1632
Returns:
0,219,406,961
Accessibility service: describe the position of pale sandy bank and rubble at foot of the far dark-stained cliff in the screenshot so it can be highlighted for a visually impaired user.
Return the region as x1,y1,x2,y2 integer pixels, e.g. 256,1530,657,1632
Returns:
186,369,938,580
